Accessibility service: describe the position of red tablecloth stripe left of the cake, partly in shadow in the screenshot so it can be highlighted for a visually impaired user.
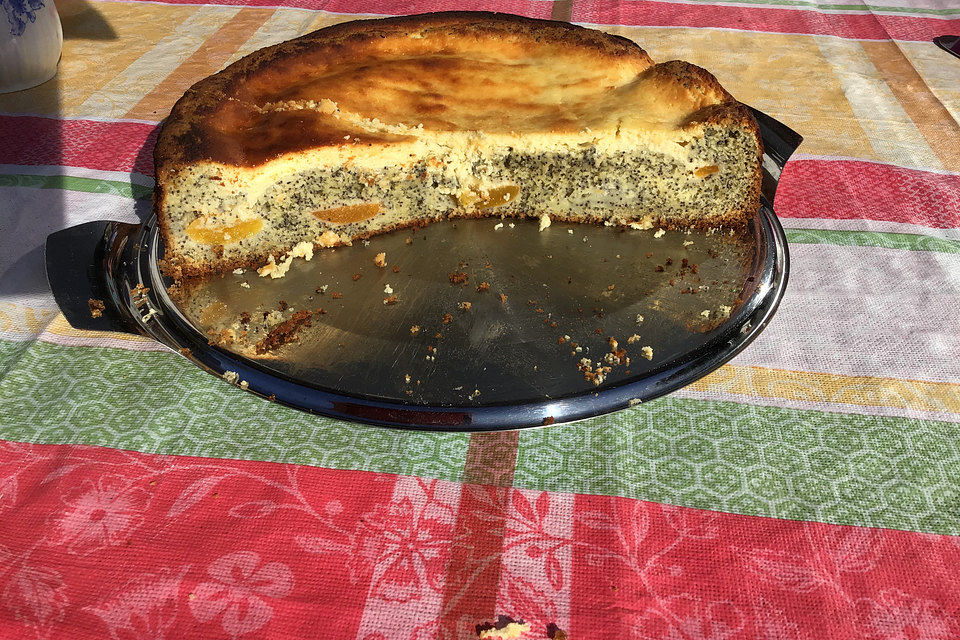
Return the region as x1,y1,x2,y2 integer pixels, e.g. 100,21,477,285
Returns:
0,116,157,176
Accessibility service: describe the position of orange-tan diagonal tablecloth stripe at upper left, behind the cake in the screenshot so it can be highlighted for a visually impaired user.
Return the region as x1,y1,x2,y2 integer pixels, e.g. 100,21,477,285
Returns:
126,7,274,120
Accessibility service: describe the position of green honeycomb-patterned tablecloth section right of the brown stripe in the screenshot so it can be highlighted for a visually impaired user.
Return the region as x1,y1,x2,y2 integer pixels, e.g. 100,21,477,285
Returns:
514,398,960,535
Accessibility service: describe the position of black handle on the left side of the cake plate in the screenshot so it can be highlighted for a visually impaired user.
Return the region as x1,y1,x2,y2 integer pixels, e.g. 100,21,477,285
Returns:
44,220,142,335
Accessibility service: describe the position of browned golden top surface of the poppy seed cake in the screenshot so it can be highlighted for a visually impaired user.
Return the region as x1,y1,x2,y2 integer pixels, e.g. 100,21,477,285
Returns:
156,13,736,175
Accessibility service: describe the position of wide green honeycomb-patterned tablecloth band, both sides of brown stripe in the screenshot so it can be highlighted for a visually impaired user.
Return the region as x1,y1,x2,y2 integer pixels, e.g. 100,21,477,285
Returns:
0,342,960,534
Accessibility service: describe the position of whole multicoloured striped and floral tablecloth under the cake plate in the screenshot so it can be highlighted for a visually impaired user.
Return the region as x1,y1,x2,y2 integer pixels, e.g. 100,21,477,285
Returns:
0,0,960,640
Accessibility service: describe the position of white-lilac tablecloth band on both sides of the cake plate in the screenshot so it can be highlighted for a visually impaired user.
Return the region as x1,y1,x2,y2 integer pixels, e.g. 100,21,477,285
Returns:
0,187,960,382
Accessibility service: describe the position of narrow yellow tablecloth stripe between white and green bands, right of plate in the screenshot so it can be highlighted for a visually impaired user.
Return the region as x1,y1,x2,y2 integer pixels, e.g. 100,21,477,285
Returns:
689,365,960,413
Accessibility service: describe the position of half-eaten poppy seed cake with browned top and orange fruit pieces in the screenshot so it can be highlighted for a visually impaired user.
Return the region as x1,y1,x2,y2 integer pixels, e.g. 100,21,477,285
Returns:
154,12,762,277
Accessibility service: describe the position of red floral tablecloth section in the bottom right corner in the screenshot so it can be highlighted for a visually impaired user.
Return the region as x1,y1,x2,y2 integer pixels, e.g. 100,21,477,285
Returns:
570,495,960,640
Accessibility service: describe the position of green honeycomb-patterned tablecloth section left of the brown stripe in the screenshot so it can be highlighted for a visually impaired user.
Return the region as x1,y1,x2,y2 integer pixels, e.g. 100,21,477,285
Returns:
0,341,468,480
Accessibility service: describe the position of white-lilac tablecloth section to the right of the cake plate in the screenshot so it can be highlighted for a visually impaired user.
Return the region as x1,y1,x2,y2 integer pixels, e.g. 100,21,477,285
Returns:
733,244,960,382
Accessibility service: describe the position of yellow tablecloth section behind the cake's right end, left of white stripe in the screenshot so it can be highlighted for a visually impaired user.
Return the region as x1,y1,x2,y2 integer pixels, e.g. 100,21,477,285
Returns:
604,27,880,166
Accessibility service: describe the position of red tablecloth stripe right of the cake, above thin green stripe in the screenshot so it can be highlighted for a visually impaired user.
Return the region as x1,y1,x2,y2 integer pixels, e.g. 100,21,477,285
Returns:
775,160,960,229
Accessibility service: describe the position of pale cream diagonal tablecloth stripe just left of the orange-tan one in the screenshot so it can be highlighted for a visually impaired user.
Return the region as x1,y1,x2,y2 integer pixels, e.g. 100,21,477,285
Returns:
77,3,240,118
